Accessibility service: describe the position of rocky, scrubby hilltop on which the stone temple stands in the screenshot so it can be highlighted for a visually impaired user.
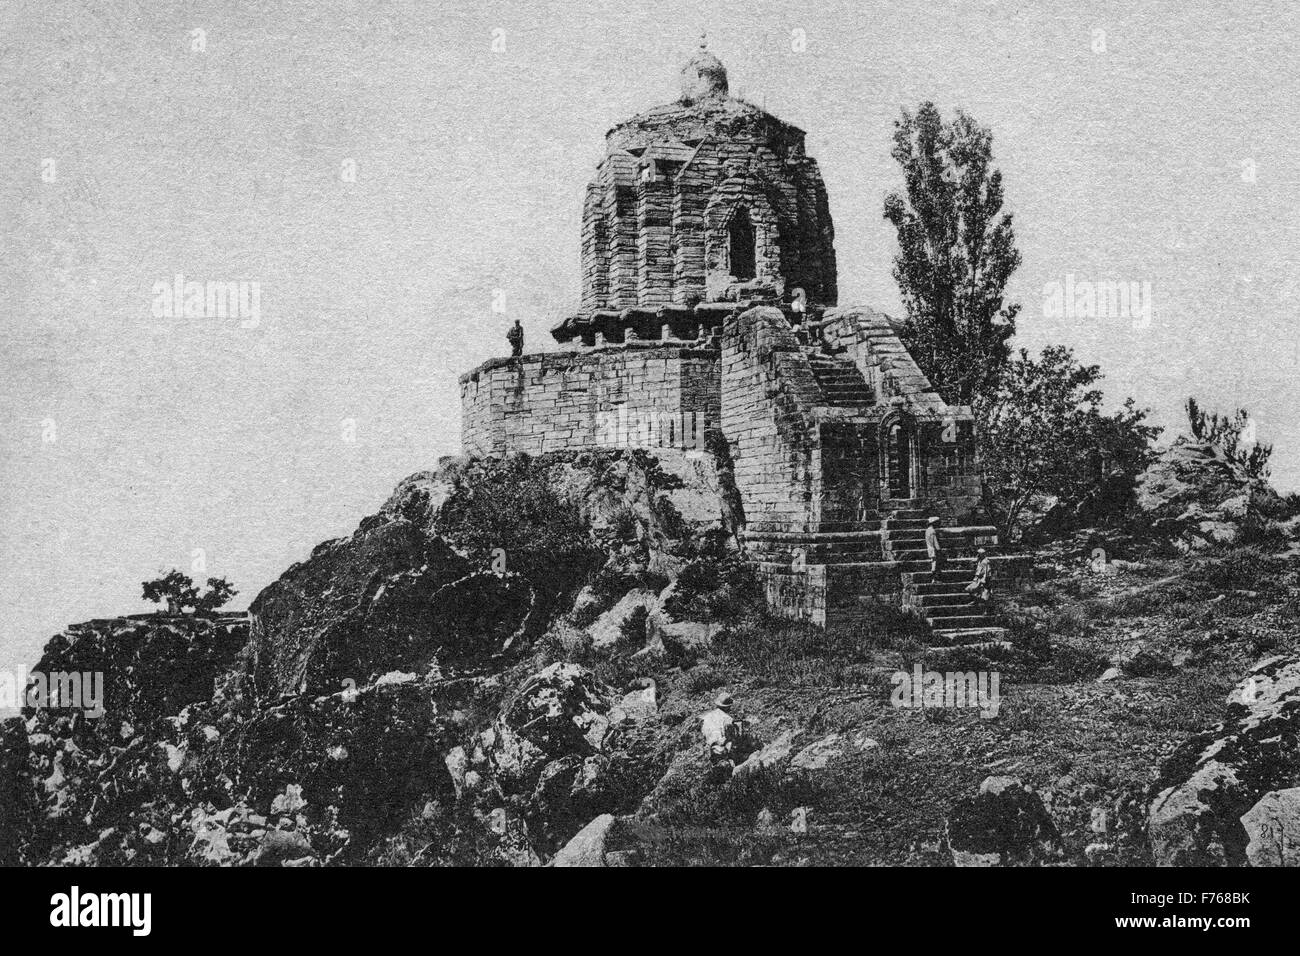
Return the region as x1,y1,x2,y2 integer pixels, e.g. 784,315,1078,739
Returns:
0,444,1300,865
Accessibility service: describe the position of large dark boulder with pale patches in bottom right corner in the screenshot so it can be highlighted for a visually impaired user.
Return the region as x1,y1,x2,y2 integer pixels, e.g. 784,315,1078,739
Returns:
1147,657,1300,866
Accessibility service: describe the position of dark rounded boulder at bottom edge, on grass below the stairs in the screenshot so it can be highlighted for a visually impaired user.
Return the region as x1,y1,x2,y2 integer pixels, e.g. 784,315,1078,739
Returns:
944,777,1061,866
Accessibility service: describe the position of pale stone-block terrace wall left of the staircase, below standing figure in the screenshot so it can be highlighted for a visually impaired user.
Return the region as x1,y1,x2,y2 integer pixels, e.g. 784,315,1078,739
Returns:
460,342,720,455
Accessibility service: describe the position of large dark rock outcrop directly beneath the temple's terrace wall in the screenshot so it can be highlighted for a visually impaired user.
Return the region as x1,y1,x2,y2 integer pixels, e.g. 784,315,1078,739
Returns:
251,451,725,697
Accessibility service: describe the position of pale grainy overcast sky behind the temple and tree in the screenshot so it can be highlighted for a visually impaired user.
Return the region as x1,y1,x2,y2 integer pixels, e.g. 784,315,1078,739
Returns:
0,0,1300,667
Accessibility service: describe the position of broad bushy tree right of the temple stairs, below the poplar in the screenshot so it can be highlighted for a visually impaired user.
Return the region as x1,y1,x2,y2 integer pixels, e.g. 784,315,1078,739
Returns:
978,346,1161,541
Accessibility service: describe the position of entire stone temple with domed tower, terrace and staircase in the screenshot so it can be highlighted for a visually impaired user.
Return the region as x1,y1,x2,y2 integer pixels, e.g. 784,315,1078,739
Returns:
460,47,1017,640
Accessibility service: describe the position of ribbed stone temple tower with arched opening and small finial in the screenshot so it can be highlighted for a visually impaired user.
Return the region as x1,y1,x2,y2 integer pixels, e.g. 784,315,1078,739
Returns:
553,46,837,345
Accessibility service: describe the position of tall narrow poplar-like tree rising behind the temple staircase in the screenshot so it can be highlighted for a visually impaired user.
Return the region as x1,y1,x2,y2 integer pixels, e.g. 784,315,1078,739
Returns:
884,103,1021,405
